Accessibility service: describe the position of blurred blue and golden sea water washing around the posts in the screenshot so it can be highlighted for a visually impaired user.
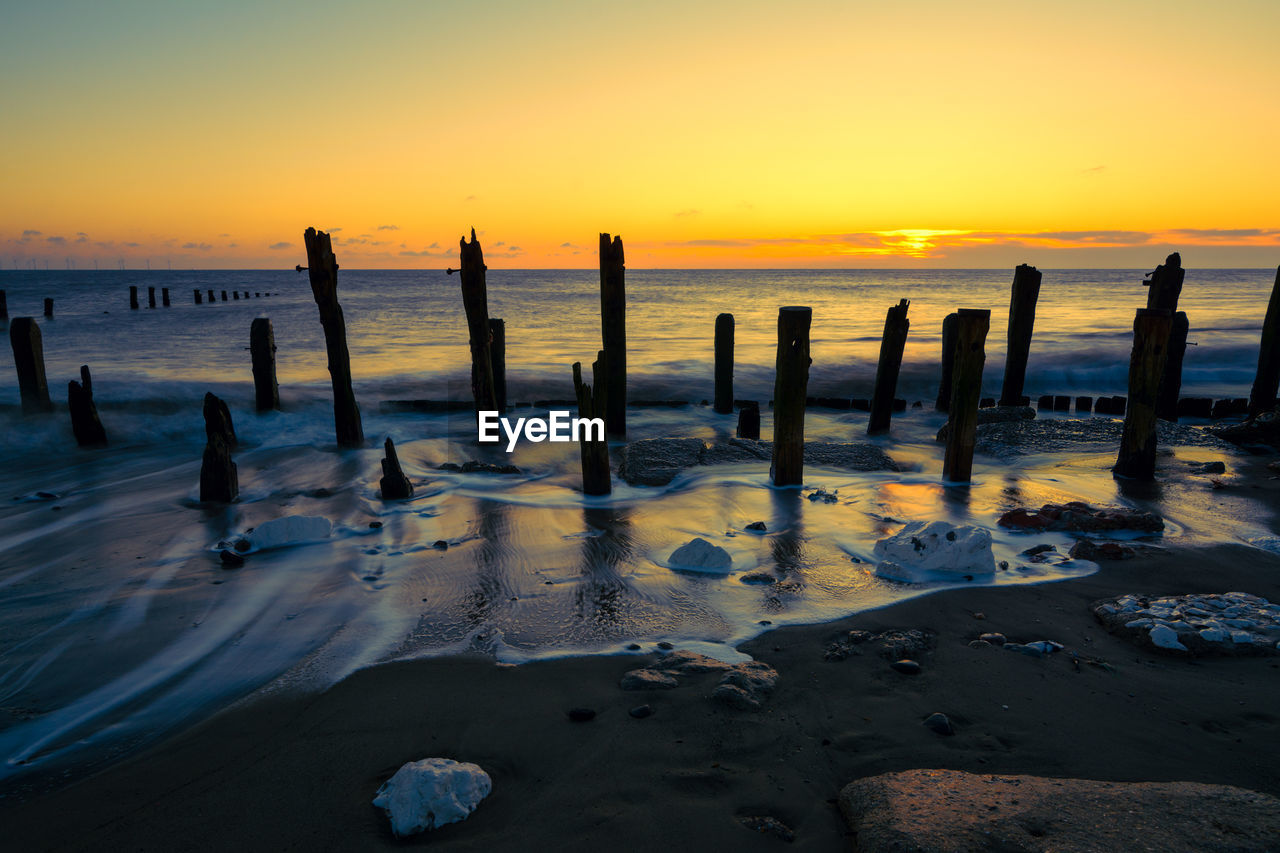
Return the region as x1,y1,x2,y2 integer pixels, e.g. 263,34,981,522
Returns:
0,269,1274,784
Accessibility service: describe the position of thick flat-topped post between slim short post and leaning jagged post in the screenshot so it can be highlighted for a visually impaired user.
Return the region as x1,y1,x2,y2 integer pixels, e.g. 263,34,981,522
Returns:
769,305,813,485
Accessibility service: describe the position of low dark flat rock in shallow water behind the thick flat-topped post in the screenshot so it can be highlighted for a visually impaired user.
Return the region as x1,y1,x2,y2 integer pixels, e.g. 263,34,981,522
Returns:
618,438,901,485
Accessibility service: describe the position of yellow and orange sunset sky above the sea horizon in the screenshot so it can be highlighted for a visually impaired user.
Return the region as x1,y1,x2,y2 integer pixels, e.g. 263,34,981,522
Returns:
0,0,1280,270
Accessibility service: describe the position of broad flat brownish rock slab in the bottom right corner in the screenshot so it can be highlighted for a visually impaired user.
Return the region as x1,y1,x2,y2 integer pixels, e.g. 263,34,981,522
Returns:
840,770,1280,853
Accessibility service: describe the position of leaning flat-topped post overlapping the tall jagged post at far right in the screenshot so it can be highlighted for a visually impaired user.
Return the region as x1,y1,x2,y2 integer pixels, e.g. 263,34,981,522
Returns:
1111,309,1172,480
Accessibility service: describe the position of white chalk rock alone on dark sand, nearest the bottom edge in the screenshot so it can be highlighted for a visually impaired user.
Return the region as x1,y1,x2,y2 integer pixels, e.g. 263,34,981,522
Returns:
374,758,493,838
